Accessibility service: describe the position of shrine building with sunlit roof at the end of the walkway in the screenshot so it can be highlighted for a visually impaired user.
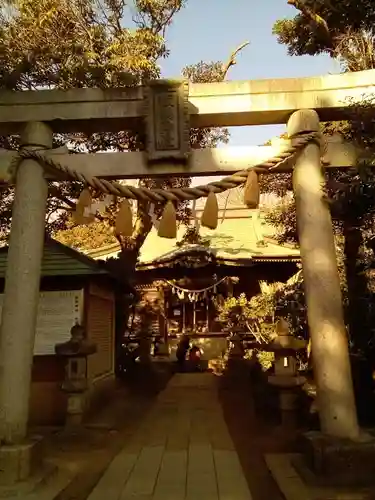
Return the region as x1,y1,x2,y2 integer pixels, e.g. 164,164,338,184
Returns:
87,189,300,359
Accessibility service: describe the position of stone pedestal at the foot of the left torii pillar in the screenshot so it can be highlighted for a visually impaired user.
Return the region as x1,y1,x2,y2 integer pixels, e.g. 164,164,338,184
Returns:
0,440,43,486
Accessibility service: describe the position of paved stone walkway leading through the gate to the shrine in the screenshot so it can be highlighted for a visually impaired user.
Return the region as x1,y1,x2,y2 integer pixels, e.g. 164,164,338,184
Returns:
87,373,251,500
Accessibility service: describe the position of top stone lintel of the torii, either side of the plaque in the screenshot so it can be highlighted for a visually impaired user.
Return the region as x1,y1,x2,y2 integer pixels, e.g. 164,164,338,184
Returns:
0,70,375,134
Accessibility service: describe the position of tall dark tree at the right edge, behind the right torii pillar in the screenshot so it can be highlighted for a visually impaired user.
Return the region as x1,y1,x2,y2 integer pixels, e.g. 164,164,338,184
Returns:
267,0,375,358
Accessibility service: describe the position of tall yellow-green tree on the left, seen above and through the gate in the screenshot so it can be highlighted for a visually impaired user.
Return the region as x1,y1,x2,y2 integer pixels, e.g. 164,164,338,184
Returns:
0,0,241,264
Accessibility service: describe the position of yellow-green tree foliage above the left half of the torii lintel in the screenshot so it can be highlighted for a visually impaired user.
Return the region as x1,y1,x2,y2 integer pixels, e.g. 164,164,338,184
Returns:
0,0,170,90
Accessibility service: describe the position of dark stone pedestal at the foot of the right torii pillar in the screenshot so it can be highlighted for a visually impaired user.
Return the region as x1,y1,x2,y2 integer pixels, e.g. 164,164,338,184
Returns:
295,432,375,487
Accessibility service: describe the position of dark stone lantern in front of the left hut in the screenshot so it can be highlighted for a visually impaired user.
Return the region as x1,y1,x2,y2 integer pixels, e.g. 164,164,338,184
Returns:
55,324,96,426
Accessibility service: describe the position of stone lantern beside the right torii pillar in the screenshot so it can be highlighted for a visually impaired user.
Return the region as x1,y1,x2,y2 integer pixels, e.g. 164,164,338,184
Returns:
267,319,307,426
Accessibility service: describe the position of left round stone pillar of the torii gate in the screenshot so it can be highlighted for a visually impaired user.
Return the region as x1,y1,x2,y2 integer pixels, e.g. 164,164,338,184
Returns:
0,122,52,444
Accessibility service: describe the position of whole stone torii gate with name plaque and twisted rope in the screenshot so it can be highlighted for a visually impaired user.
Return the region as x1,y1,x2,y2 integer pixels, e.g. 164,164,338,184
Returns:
0,70,375,478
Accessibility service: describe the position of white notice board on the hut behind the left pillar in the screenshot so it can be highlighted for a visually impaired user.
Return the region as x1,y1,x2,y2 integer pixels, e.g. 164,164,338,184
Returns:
0,290,83,356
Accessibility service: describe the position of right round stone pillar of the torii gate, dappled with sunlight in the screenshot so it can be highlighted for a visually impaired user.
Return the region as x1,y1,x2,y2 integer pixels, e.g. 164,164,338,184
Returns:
288,110,359,440
